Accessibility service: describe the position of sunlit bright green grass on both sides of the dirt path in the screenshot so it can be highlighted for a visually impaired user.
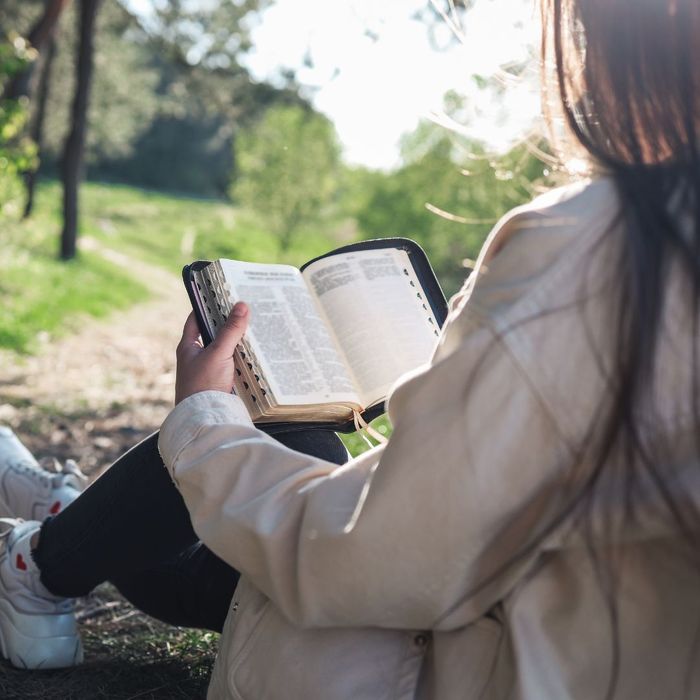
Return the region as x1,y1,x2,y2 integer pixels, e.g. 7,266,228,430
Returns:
0,182,356,353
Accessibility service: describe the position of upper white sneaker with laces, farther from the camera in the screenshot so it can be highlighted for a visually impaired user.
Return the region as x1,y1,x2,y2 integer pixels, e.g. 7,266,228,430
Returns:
0,426,86,521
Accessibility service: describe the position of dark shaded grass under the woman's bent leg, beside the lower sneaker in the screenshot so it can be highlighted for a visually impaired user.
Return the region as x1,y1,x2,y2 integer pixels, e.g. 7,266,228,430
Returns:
0,585,218,700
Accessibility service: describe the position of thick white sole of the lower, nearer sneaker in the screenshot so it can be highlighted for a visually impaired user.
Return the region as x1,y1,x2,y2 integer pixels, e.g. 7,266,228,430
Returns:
0,600,83,669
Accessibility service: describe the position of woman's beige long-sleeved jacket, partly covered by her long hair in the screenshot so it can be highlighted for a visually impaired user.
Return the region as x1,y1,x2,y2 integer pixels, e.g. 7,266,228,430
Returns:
160,180,700,700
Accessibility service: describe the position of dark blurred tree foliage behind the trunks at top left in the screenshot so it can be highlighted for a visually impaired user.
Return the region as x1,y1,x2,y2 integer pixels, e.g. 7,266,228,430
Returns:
0,0,304,196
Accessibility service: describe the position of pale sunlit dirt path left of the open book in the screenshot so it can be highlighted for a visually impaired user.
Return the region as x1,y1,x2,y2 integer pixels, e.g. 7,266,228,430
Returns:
0,239,189,473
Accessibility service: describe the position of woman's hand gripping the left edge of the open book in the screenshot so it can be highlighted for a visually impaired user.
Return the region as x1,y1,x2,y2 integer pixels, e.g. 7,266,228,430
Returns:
175,301,249,404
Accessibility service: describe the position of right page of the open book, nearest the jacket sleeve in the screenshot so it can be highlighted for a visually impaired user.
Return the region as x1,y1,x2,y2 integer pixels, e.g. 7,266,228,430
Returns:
303,248,439,406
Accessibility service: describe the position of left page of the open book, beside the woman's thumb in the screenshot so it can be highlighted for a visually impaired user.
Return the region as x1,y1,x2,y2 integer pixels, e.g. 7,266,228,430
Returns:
219,260,359,405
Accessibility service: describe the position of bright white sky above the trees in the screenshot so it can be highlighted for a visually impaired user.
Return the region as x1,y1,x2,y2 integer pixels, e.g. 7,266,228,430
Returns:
129,0,539,169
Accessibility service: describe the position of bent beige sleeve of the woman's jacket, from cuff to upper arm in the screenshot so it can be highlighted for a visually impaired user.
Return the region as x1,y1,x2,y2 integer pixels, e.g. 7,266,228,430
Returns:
159,278,562,629
